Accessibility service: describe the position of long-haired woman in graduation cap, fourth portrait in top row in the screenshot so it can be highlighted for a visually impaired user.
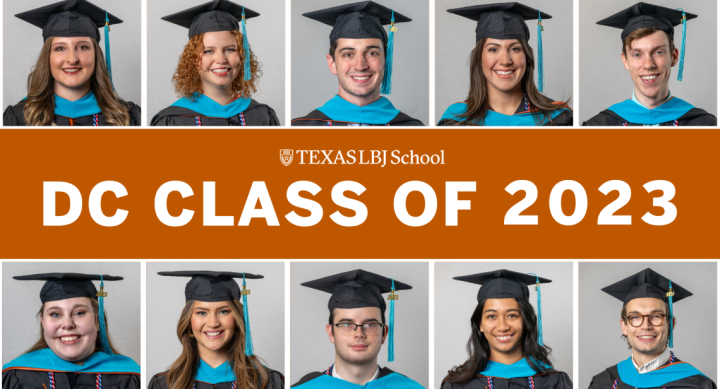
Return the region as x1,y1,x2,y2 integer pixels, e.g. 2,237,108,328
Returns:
438,3,572,126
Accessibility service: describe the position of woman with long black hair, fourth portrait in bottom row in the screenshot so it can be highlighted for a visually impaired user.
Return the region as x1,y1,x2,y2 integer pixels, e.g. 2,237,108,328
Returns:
442,269,573,389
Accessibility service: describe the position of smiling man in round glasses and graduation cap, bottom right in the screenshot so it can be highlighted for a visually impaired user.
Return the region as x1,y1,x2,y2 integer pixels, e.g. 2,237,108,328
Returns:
590,268,716,389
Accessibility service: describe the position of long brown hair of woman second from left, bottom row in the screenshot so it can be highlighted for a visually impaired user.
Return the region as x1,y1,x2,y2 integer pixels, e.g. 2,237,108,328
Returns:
167,300,268,389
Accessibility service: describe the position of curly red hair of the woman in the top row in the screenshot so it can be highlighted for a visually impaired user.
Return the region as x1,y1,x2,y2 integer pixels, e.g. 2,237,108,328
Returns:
172,30,262,98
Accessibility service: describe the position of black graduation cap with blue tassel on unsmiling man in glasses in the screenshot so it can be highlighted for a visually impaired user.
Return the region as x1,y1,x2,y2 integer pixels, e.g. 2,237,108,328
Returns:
301,269,412,362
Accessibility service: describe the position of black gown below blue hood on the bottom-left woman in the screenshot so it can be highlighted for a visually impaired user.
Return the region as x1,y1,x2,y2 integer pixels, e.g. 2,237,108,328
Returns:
2,369,140,389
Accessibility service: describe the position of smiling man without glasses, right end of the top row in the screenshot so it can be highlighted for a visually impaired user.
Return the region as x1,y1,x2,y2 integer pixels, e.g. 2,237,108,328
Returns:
583,3,717,126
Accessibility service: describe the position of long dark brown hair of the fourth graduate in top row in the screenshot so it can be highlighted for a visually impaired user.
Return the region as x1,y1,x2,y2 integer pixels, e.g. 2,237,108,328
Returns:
456,38,567,125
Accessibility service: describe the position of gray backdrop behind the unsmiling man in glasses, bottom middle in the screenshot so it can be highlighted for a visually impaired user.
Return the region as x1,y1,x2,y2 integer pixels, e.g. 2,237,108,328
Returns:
287,262,429,388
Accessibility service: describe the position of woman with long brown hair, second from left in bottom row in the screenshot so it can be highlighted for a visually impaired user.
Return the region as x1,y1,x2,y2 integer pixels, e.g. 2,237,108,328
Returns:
148,271,285,389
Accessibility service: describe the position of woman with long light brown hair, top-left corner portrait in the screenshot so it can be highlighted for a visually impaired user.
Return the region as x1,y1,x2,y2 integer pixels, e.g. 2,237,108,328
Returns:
3,0,140,126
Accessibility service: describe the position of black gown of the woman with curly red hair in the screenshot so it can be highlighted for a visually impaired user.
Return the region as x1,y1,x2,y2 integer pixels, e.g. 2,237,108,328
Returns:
150,99,281,127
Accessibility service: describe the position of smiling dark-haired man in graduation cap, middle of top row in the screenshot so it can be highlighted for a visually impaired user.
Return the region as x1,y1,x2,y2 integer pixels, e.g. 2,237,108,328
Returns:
292,1,423,126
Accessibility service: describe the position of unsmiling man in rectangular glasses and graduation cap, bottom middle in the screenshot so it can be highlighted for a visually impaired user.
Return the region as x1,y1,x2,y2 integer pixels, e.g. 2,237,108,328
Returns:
293,270,422,389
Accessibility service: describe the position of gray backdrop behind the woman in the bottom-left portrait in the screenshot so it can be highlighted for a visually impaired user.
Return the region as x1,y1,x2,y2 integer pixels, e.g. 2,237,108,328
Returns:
2,261,140,364
